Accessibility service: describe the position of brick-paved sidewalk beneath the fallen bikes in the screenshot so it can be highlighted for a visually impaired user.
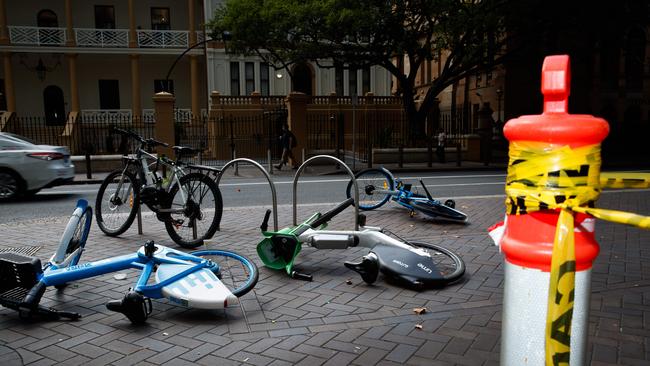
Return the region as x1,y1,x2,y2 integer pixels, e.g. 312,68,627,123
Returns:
0,191,650,366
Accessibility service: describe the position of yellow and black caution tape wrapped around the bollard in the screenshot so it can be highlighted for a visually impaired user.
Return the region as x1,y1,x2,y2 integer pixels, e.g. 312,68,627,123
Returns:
506,142,650,365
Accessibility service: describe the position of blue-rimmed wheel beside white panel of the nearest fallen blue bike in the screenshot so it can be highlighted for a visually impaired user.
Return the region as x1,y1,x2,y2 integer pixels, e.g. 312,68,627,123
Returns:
190,250,259,297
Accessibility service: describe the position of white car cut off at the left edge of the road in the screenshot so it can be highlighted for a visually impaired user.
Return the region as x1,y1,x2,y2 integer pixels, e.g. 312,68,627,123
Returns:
0,132,74,201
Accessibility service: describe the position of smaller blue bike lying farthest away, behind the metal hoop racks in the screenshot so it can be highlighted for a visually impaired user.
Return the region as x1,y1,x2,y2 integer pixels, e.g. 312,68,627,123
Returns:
346,167,467,223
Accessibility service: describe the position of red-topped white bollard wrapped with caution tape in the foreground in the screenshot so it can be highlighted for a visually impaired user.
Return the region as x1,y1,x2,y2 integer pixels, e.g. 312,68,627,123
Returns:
500,56,609,366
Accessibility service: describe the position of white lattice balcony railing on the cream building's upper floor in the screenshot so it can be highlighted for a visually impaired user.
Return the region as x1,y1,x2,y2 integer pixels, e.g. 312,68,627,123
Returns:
8,26,205,48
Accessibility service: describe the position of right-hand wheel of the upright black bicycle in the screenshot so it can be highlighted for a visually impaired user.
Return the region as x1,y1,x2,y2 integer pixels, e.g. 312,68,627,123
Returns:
165,173,223,248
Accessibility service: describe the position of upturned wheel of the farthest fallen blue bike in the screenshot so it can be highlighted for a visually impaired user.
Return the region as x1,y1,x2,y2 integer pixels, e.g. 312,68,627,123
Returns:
345,169,395,210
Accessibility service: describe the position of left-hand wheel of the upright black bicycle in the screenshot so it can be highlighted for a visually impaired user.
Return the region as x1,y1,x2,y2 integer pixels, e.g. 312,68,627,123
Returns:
95,170,140,236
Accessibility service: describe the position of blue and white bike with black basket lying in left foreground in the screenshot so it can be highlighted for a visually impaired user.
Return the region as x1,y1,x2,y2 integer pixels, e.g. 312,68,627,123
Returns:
0,200,258,324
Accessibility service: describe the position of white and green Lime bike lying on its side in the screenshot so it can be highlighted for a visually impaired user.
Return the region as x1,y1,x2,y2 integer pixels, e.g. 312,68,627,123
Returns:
257,198,465,290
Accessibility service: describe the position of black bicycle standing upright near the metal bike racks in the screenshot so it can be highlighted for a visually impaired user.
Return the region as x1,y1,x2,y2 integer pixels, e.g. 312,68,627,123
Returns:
95,128,223,248
